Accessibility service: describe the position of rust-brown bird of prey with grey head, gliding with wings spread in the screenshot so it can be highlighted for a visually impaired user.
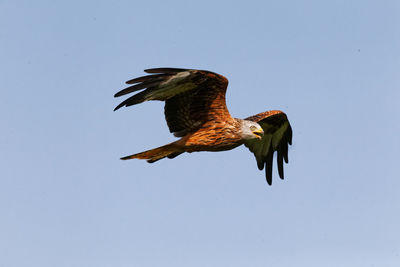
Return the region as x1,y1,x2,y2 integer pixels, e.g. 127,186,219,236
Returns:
114,68,292,185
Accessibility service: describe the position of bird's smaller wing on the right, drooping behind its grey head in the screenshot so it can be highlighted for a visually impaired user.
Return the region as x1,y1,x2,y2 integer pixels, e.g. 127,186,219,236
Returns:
244,110,292,185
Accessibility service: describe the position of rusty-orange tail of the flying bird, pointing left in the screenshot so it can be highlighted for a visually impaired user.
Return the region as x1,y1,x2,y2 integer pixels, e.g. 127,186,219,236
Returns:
121,143,185,163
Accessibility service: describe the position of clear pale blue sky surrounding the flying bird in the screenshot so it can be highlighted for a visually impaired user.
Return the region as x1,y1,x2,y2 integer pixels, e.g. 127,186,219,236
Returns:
0,0,400,267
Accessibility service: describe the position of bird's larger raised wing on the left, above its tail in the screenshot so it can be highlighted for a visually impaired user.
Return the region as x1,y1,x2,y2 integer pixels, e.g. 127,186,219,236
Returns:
114,68,230,137
